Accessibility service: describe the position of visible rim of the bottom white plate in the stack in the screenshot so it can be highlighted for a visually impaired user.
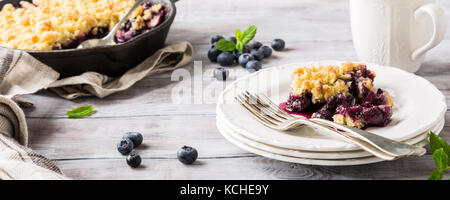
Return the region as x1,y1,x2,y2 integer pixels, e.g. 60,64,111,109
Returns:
217,122,438,166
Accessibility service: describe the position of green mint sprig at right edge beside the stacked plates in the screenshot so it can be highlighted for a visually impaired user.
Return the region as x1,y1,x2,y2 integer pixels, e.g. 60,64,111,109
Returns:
428,131,450,180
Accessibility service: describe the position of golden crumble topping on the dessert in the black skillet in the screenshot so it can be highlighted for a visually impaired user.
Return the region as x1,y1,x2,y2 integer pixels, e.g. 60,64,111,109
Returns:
0,0,139,50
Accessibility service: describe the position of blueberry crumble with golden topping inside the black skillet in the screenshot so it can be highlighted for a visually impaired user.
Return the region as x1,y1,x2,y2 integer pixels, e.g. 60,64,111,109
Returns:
0,0,166,50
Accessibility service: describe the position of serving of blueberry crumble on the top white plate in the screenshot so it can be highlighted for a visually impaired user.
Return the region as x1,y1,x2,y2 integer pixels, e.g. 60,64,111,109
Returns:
280,62,393,128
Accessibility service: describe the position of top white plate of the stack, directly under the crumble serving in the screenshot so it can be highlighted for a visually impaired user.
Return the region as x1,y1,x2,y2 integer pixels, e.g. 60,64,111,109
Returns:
216,61,447,151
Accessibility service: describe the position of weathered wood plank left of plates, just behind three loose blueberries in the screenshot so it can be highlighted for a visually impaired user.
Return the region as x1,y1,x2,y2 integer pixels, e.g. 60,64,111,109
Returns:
28,112,450,159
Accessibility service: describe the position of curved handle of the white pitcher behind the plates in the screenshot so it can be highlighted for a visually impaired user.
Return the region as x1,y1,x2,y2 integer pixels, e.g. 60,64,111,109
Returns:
411,3,447,60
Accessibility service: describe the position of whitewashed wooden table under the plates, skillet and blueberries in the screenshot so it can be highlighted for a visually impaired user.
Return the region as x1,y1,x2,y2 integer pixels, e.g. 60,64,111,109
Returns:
25,0,450,179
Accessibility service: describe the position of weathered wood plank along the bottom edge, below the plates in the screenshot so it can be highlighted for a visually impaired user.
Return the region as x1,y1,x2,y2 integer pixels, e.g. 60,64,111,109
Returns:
56,155,442,180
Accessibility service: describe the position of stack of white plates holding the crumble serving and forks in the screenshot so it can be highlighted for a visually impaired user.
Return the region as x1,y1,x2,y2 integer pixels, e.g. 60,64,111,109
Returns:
217,61,447,165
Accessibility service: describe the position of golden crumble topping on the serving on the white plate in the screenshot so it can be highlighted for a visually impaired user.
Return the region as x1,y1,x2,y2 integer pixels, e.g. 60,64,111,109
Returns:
291,62,375,104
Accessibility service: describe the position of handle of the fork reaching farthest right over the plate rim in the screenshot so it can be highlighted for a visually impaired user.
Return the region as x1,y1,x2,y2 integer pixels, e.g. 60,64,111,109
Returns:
309,118,426,158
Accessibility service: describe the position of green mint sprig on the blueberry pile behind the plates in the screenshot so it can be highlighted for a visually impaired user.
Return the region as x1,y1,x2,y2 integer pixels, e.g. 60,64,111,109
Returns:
216,25,258,51
